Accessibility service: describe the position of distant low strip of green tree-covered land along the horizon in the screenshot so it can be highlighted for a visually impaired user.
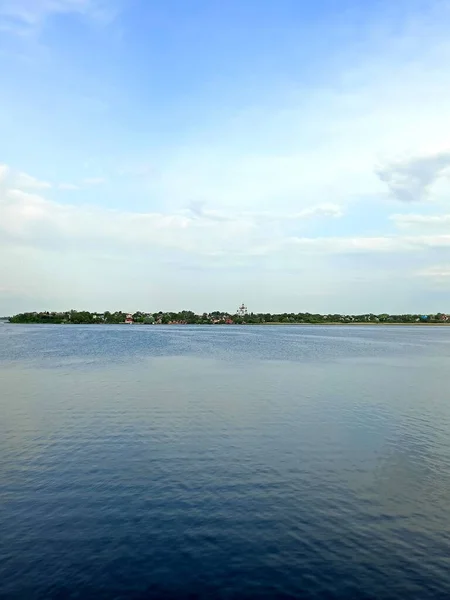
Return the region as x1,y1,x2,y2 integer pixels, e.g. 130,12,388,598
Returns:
5,305,450,325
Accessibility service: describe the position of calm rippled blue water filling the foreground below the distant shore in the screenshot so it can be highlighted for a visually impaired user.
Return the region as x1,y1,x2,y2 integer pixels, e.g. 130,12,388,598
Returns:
0,325,450,600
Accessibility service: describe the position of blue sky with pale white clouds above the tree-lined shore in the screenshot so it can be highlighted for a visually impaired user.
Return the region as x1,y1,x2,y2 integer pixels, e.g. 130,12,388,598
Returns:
0,0,450,316
